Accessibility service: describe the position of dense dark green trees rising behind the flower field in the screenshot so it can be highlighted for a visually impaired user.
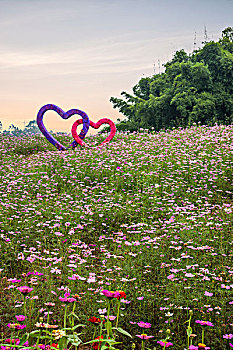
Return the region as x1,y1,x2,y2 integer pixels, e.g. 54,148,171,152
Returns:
110,27,233,131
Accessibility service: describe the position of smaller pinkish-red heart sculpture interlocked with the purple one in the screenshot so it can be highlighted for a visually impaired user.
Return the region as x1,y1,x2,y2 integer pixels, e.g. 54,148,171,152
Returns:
71,118,116,147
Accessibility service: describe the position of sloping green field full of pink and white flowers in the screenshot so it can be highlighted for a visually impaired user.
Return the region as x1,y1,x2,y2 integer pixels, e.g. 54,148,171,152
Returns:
0,125,233,350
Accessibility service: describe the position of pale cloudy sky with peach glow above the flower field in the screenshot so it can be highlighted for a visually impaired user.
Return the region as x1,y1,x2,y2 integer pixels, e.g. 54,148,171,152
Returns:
0,0,233,132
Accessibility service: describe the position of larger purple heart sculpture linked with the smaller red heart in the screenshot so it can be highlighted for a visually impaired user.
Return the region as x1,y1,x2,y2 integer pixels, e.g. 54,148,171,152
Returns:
37,104,89,151
